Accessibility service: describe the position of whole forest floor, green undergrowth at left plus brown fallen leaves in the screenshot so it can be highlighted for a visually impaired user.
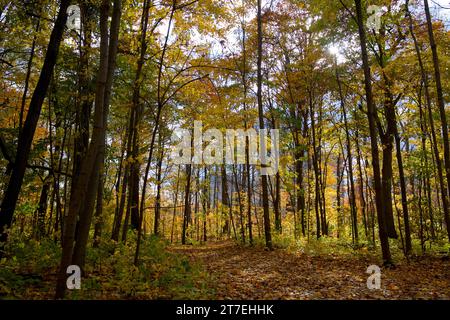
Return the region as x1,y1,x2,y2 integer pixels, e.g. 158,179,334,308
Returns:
0,238,450,300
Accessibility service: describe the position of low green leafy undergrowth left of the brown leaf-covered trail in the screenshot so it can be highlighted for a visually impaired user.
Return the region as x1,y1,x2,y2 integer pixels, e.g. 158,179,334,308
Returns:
0,232,212,299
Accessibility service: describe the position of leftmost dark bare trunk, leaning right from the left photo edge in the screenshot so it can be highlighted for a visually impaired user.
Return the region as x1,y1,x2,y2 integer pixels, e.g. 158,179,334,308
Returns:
0,0,71,251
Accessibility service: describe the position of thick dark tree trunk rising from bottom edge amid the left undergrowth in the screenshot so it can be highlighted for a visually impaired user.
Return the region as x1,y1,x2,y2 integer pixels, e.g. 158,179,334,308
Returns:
55,0,122,299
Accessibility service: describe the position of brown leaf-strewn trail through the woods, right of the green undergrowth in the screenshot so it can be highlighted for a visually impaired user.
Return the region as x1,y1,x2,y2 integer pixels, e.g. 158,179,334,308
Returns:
171,241,450,300
